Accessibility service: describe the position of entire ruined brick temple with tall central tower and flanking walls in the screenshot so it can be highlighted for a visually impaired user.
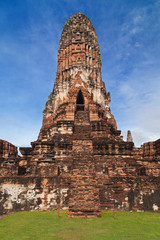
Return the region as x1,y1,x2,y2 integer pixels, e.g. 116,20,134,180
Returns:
0,13,160,217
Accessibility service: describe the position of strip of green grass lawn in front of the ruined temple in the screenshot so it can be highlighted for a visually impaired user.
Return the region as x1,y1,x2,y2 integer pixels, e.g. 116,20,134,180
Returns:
0,211,160,240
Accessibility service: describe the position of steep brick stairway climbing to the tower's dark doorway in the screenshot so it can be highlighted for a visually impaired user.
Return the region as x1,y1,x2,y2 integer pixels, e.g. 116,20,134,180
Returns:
69,111,100,217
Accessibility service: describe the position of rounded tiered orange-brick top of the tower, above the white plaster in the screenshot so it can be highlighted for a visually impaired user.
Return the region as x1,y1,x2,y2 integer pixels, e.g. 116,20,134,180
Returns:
56,13,101,83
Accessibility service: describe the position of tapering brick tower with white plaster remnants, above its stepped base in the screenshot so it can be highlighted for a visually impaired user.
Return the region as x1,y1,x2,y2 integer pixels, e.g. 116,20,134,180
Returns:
42,13,113,134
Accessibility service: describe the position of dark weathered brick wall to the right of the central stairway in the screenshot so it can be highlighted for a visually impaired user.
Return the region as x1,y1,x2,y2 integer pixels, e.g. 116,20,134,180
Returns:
96,155,160,211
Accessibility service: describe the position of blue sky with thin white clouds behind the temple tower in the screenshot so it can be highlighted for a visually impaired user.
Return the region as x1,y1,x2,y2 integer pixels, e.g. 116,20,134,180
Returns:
0,0,160,146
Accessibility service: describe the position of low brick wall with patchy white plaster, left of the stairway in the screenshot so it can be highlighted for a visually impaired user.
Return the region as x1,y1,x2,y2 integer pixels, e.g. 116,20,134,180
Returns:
0,176,69,214
